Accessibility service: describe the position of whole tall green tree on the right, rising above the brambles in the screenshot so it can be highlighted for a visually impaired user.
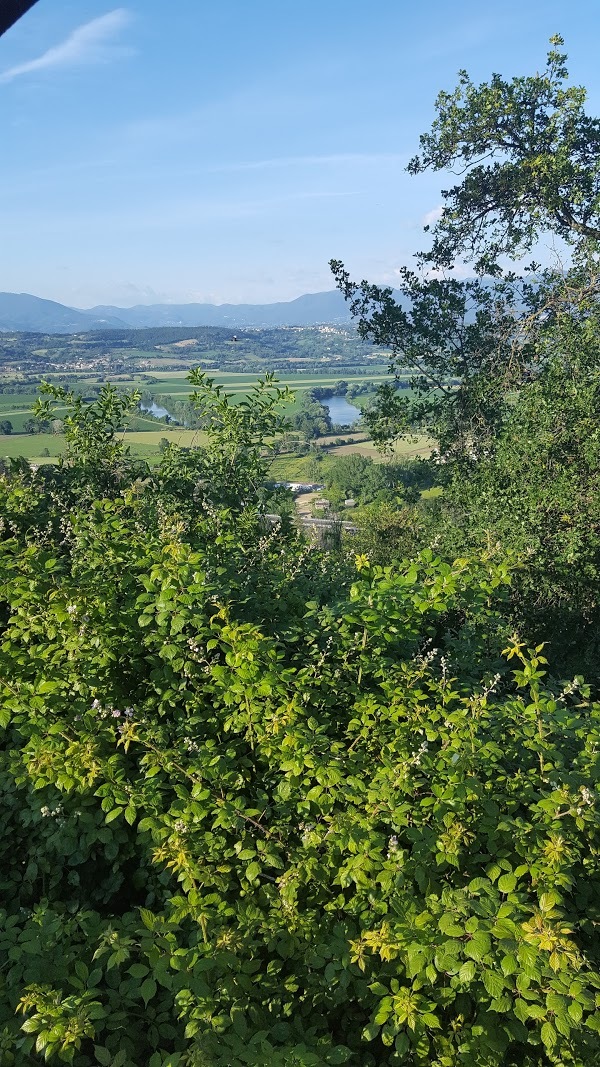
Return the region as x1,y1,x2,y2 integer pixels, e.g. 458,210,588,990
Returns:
331,37,600,673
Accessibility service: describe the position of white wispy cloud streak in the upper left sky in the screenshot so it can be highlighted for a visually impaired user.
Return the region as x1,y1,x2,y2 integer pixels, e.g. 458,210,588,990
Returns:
0,7,131,82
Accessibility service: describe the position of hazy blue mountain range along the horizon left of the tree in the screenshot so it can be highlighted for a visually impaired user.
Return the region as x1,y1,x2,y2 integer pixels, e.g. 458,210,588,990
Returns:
0,289,371,333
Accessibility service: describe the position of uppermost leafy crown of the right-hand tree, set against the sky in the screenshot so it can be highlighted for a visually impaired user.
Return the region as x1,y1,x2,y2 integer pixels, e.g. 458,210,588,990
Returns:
408,36,600,273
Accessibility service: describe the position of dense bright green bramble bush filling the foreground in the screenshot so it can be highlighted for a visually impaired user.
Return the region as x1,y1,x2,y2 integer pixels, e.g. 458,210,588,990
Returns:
0,378,600,1067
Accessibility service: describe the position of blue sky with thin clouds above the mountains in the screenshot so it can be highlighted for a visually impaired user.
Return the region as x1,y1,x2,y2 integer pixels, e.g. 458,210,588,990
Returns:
0,0,600,307
